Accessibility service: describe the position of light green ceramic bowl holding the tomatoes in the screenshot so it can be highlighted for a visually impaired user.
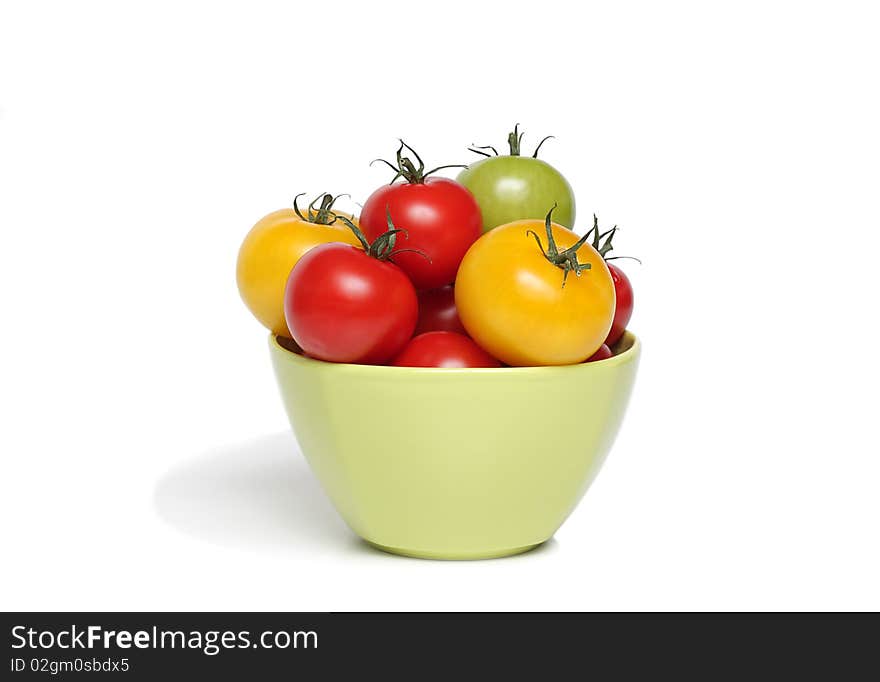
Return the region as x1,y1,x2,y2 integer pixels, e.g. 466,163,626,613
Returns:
270,333,639,559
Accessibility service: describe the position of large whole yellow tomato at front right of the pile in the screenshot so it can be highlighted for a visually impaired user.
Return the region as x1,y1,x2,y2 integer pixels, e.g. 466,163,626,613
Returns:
455,209,615,366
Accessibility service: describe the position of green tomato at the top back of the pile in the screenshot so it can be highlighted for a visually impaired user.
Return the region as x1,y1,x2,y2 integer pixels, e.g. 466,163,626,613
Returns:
457,126,575,231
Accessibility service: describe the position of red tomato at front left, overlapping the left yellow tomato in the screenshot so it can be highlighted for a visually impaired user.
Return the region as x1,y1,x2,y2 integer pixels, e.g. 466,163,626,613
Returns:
284,221,419,364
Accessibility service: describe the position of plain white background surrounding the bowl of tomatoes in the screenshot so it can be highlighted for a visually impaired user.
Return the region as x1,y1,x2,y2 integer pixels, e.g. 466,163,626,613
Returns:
0,0,880,610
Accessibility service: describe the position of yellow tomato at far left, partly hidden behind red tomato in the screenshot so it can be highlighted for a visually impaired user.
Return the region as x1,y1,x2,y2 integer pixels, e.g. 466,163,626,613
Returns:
236,194,359,336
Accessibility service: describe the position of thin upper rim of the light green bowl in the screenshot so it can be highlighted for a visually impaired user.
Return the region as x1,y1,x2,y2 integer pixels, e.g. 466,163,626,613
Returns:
269,330,641,376
